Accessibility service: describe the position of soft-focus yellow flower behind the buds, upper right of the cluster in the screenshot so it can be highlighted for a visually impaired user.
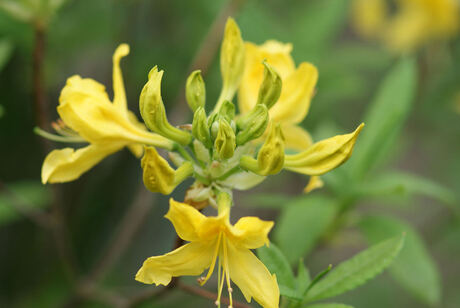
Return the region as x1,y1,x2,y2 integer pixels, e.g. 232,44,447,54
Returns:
238,41,318,150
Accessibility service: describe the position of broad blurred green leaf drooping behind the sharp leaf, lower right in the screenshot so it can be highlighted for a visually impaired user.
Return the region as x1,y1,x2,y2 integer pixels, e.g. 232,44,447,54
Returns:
360,216,441,305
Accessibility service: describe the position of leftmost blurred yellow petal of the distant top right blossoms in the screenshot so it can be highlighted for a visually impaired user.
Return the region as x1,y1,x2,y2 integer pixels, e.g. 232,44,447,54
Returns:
351,0,388,37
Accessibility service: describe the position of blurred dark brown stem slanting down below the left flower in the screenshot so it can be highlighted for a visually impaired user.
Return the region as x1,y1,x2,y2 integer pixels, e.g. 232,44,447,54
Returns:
87,183,155,282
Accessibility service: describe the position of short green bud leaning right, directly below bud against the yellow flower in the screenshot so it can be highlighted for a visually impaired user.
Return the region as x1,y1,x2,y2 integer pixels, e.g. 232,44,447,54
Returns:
236,104,268,145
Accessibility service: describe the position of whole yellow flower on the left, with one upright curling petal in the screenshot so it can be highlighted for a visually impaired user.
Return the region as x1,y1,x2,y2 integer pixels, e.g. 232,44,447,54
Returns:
42,44,173,183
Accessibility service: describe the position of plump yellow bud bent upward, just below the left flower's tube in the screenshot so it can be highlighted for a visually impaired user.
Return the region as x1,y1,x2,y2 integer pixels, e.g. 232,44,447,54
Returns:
141,147,193,195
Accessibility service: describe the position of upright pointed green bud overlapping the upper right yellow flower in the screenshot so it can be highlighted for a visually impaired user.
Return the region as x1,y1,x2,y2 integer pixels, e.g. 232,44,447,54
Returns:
257,61,282,109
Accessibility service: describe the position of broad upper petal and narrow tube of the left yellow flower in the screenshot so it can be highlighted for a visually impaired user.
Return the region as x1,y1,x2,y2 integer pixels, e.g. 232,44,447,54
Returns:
58,76,172,149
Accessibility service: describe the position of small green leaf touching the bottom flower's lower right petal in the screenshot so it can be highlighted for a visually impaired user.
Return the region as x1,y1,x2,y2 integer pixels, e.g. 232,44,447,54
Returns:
257,243,302,300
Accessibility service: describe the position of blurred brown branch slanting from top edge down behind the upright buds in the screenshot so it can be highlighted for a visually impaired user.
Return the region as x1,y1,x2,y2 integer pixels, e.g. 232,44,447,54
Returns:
169,0,245,123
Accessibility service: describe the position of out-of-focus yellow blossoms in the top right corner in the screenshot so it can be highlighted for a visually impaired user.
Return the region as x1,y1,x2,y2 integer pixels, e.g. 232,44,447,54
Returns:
352,0,460,53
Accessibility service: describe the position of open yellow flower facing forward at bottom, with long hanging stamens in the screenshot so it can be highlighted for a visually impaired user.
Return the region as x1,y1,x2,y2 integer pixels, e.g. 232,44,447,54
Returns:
136,199,279,308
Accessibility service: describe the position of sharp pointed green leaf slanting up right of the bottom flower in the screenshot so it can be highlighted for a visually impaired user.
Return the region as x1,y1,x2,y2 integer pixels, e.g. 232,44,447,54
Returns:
305,235,404,301
